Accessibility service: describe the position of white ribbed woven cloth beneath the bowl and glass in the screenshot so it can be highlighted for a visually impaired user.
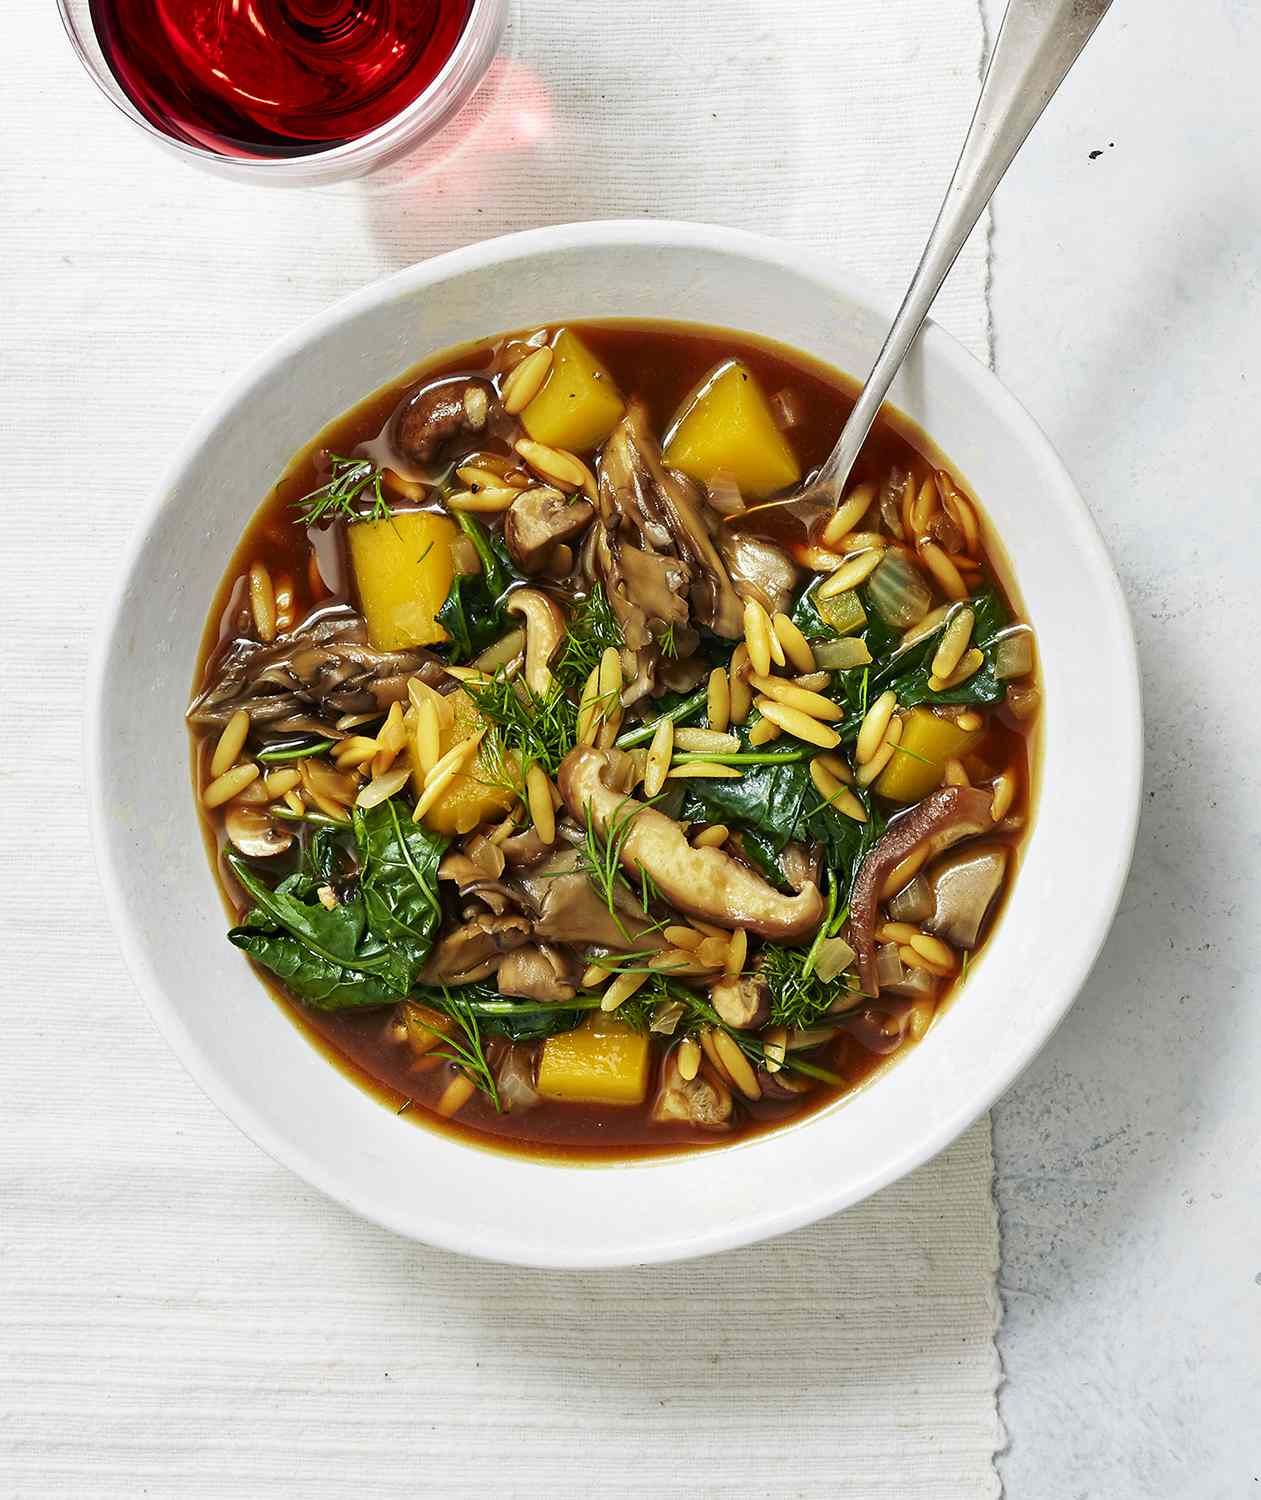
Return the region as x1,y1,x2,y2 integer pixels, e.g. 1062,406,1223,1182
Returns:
0,0,1000,1500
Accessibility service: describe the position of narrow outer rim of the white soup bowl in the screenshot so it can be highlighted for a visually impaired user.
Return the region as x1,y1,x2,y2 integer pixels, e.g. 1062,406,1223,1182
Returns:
84,219,1143,1271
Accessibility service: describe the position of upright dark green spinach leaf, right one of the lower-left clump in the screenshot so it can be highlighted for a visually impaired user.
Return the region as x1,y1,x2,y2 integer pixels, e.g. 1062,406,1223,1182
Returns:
354,798,447,990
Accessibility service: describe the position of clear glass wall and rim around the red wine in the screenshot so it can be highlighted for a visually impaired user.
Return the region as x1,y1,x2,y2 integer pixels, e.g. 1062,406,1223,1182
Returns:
57,0,508,183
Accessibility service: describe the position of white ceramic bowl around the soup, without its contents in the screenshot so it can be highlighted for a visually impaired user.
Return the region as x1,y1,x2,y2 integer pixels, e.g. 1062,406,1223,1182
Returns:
87,222,1141,1268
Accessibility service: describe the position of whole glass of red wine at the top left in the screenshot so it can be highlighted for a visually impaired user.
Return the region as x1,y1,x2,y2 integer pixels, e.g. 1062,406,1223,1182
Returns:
58,0,508,185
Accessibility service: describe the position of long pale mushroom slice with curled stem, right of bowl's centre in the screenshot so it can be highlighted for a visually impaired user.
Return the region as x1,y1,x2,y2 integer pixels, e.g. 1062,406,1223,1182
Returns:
556,746,821,942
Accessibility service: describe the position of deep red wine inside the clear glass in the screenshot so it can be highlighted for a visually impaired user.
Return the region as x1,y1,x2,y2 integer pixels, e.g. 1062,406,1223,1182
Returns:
90,0,472,156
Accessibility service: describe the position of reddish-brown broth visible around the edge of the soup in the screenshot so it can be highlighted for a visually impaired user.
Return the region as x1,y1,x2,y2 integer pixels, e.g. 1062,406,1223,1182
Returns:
186,321,1038,1161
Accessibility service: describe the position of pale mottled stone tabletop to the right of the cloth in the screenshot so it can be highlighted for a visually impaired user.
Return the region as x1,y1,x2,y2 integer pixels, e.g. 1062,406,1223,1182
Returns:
991,0,1261,1500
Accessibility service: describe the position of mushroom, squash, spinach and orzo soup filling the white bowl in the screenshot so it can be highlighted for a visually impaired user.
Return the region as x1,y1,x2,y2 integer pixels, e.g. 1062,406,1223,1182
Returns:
189,323,1039,1160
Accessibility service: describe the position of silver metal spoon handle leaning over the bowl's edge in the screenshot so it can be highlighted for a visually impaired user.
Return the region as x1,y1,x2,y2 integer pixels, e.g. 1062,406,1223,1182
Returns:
811,0,1111,503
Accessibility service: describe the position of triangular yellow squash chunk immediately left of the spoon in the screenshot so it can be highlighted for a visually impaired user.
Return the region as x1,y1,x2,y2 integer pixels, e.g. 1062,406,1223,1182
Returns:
664,360,801,500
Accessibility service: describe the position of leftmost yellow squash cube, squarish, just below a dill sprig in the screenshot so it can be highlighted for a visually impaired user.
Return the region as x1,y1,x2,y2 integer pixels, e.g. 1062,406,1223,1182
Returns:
346,510,456,651
